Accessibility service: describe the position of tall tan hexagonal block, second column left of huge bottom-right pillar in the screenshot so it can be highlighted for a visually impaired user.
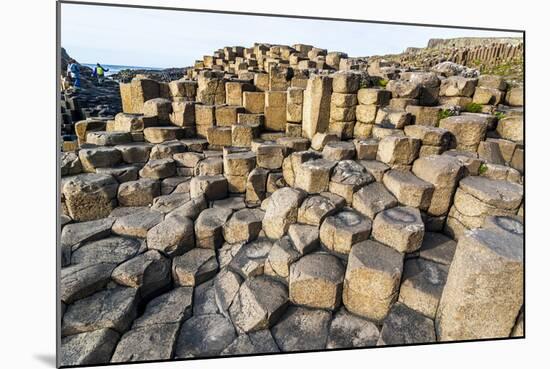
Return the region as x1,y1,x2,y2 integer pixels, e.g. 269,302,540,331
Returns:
342,240,403,321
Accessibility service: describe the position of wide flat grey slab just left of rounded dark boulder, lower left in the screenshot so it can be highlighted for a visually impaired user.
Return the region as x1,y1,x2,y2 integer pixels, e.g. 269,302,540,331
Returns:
71,237,142,265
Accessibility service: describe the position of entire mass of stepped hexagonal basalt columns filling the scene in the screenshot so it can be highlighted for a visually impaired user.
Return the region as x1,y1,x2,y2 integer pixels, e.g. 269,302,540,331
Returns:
60,40,524,365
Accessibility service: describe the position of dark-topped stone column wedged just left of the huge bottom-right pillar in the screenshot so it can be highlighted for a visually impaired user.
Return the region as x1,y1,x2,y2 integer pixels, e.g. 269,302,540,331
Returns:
399,258,449,319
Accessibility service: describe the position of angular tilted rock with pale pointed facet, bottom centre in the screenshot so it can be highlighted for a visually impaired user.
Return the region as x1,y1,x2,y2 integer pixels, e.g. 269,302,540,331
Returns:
229,276,288,332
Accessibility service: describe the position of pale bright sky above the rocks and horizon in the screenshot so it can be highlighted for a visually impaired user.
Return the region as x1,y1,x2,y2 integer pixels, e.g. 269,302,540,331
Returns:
61,4,521,68
